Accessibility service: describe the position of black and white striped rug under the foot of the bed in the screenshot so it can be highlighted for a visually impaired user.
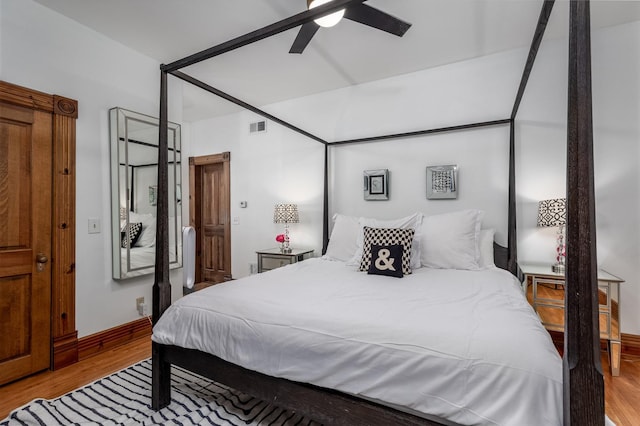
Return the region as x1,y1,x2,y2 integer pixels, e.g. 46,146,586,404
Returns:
0,360,317,426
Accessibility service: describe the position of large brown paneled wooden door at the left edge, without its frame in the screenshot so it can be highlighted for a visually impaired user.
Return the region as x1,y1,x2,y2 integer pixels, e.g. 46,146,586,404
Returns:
0,102,53,384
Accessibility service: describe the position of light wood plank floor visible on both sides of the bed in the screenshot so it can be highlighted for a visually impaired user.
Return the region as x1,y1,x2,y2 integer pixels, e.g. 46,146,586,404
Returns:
0,338,640,426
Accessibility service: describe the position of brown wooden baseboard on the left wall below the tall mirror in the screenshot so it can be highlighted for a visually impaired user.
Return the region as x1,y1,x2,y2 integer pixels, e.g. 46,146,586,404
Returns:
78,317,151,360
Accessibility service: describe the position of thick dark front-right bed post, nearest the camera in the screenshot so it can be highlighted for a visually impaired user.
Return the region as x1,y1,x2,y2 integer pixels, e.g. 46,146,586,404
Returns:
564,0,604,426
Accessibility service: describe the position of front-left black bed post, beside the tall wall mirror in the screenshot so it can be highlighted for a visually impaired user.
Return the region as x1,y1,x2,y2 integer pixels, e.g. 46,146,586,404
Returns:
151,70,171,410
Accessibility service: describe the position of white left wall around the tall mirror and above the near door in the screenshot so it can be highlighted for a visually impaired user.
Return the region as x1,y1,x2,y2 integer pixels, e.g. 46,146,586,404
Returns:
0,0,182,337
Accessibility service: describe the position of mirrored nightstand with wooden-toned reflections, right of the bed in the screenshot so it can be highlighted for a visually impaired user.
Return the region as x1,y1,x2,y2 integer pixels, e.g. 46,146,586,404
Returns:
520,263,624,376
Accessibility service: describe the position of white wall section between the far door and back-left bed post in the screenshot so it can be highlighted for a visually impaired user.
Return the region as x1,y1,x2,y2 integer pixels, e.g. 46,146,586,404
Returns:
184,112,324,278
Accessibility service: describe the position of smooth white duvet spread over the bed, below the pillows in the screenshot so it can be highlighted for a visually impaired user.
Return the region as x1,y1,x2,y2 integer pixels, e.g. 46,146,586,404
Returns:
153,258,562,425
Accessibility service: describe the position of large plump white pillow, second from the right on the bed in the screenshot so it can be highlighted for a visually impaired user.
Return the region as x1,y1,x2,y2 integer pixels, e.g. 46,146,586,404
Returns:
419,210,483,270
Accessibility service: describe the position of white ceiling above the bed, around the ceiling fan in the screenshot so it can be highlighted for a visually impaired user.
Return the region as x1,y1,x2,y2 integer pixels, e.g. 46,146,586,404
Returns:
36,0,640,121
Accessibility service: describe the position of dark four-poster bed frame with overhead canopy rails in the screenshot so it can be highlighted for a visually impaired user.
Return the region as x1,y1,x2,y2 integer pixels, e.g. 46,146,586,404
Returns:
152,0,604,426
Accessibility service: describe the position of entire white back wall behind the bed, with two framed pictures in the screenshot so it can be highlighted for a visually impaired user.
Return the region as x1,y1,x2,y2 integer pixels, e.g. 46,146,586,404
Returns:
190,23,640,334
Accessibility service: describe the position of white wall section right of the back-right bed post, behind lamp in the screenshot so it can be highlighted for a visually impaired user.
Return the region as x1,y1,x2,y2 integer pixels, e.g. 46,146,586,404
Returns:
516,22,640,334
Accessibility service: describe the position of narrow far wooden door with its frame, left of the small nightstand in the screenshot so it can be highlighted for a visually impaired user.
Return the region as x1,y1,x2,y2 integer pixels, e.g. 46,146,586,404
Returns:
189,152,231,289
